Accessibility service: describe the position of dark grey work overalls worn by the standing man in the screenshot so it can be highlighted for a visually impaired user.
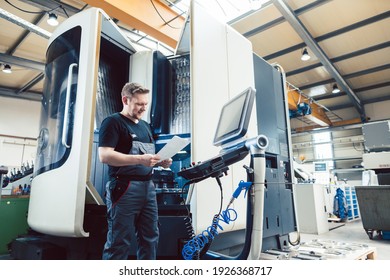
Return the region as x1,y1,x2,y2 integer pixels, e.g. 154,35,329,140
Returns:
103,141,159,260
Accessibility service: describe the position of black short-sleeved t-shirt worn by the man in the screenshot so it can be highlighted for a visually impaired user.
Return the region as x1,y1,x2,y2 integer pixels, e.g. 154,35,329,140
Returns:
99,113,154,177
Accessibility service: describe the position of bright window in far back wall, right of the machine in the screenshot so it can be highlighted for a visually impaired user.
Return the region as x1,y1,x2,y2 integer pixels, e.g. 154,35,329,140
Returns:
312,132,334,169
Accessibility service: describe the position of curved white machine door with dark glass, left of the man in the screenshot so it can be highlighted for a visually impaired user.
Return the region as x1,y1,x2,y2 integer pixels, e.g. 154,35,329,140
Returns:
27,8,137,237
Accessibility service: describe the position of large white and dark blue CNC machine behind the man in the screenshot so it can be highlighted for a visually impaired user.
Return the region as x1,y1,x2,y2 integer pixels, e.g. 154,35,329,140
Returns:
13,1,296,259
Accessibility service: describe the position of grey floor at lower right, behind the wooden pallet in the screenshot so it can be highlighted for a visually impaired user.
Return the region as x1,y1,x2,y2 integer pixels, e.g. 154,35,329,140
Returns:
300,219,390,260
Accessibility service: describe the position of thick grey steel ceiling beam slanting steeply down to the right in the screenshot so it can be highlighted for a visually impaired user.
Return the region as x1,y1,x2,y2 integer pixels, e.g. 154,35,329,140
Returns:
273,0,366,121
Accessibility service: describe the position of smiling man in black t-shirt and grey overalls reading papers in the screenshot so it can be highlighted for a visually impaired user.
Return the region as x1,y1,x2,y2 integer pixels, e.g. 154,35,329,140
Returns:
99,83,172,260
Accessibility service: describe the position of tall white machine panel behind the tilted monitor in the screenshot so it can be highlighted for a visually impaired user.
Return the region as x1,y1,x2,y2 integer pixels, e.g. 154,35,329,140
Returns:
191,1,257,233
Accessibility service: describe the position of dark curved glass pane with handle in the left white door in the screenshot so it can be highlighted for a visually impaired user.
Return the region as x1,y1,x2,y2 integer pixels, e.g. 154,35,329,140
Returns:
35,26,81,175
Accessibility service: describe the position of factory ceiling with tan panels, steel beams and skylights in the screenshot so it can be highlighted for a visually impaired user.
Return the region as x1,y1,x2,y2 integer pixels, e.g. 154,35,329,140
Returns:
0,0,390,132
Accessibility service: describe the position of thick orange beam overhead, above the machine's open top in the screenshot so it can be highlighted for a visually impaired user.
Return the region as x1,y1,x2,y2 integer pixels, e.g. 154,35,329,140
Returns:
84,0,185,48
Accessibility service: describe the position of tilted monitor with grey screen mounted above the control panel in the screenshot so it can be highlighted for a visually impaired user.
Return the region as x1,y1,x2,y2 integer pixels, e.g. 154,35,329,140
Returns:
214,87,256,146
